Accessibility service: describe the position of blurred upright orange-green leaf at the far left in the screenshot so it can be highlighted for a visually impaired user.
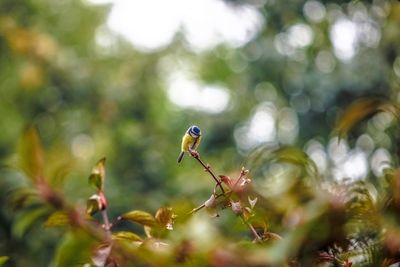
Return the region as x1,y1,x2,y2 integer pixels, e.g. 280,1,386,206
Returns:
19,127,44,181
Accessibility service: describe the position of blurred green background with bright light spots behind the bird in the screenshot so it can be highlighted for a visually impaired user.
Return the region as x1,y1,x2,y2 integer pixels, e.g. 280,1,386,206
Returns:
0,0,400,266
